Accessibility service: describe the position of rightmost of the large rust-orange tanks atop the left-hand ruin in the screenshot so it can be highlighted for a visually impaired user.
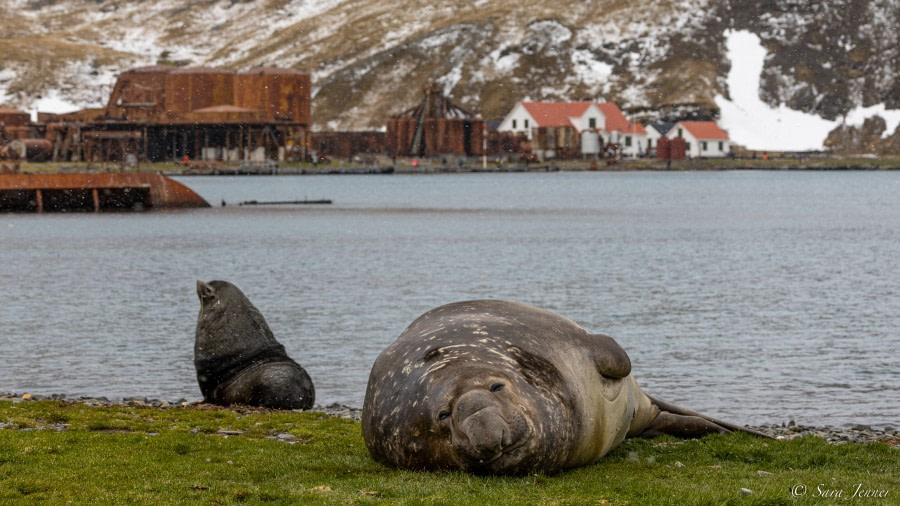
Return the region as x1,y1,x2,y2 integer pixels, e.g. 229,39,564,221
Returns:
234,67,311,124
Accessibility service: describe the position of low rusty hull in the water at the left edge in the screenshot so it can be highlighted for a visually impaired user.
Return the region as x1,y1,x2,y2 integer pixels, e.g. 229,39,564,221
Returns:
0,173,209,212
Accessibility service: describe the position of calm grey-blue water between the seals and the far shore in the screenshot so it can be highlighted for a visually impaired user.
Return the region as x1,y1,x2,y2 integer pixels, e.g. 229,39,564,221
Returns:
0,172,900,426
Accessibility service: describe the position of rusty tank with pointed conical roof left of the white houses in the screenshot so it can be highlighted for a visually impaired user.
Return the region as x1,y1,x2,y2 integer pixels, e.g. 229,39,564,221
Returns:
386,83,484,157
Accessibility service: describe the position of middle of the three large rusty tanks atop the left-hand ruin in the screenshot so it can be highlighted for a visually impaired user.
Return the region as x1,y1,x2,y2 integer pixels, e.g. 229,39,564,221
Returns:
165,67,234,119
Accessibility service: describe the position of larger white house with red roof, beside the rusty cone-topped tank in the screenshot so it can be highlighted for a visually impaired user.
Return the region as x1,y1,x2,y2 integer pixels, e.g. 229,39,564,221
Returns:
497,101,647,156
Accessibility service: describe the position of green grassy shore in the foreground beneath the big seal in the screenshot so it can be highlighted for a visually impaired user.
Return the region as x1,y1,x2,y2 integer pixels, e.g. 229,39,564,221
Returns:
0,401,900,505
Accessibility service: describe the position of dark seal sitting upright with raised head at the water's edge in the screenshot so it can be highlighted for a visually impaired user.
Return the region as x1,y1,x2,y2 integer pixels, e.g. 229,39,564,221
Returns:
194,280,316,409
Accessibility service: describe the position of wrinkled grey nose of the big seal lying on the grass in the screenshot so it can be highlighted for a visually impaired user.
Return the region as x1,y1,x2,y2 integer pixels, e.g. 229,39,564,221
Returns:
454,390,511,458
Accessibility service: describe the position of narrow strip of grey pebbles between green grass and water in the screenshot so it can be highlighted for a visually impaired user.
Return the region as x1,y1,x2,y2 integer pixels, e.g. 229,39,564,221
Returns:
0,392,900,449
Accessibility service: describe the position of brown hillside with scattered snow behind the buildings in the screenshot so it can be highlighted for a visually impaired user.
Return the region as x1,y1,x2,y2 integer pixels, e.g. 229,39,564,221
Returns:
0,0,900,134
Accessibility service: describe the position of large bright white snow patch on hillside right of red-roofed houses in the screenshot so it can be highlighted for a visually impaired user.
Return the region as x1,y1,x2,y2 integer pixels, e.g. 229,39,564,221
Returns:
715,30,900,151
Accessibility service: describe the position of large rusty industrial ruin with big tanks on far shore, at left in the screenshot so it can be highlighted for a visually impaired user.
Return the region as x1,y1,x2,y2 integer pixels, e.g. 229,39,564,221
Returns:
0,66,312,162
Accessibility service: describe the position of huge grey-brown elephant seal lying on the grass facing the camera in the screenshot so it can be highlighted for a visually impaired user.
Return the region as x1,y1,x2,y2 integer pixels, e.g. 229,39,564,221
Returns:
362,300,766,474
